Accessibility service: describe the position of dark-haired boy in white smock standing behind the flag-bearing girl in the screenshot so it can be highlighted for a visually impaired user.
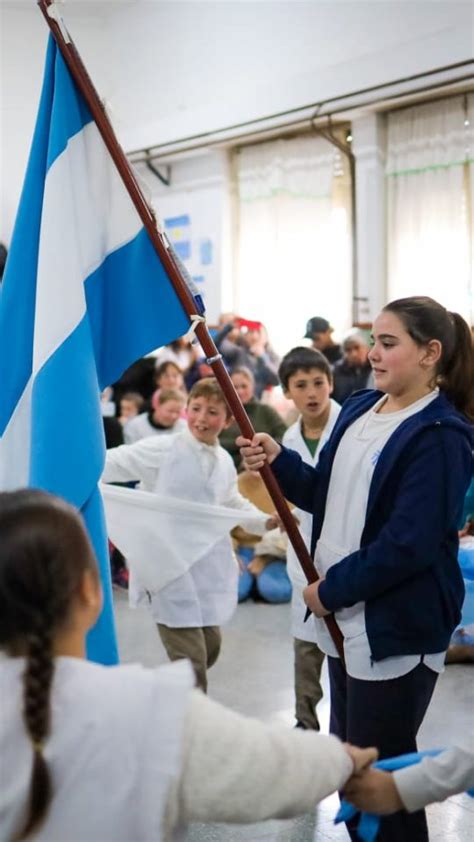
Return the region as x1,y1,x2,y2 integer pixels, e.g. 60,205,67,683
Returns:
278,347,340,731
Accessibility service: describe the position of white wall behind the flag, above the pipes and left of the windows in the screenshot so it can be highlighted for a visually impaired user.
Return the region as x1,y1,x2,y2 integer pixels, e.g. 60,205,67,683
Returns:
0,0,473,318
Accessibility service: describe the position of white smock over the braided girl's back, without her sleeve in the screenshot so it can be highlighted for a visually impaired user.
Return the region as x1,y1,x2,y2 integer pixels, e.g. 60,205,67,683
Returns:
0,658,193,842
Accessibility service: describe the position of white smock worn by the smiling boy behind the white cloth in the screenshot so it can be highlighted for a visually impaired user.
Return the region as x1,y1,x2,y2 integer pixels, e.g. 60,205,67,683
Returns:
102,429,268,628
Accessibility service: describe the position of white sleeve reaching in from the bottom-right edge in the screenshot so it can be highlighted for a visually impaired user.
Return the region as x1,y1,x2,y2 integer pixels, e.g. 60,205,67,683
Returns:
393,740,474,813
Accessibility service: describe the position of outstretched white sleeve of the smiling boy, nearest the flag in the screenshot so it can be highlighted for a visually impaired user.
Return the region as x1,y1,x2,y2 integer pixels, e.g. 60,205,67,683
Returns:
102,436,173,491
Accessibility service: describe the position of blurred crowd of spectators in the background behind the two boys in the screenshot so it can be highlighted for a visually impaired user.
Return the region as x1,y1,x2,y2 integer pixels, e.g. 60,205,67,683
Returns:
104,313,372,440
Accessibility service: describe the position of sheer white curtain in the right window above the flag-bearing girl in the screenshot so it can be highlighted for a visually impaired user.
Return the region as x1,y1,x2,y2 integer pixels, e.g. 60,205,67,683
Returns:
387,95,474,323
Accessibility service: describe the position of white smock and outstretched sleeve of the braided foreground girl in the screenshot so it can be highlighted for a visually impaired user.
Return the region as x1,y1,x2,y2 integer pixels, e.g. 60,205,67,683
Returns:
0,657,353,842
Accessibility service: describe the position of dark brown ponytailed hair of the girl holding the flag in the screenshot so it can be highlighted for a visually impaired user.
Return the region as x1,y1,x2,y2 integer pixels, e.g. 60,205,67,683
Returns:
383,296,474,421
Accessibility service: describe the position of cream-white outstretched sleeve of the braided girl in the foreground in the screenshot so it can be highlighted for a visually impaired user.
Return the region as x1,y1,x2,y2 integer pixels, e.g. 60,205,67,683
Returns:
178,690,353,822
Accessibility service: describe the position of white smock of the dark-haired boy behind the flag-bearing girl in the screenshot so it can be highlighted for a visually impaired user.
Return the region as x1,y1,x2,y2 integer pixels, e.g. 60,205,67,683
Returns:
282,399,341,643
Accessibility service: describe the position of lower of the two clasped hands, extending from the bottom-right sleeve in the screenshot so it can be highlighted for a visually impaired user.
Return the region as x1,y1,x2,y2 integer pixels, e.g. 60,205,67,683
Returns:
343,769,404,816
